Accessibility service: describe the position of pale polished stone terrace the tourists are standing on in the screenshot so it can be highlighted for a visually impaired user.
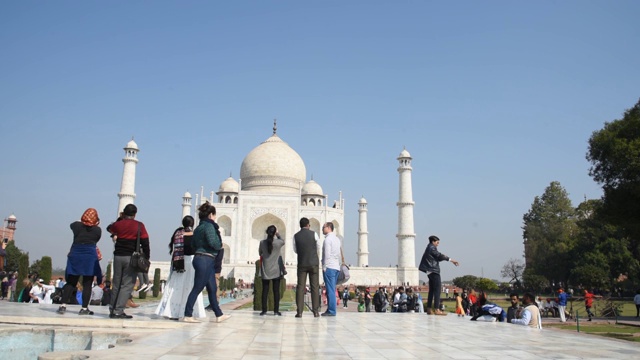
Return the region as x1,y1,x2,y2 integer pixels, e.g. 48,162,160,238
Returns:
0,302,640,360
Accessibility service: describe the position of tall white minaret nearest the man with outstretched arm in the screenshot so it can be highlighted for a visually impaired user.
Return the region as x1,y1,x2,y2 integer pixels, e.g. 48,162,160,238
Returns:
396,149,418,284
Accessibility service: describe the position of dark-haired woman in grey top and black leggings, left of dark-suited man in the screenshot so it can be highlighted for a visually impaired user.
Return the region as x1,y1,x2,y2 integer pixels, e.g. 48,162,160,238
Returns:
258,225,284,316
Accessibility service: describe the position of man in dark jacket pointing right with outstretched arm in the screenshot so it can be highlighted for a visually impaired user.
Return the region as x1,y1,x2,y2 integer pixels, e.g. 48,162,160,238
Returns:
419,235,460,315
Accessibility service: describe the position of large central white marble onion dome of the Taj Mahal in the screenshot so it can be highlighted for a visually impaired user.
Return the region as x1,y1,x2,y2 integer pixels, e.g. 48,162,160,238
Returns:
240,134,307,193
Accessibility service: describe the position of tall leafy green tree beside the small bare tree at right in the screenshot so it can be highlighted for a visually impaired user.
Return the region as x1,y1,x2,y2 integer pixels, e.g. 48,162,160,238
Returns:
522,181,577,285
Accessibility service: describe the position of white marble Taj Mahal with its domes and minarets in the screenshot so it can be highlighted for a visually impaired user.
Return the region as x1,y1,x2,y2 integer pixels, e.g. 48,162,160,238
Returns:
118,122,419,285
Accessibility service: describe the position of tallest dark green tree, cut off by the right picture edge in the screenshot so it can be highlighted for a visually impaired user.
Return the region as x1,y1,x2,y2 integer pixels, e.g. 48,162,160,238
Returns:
587,100,640,277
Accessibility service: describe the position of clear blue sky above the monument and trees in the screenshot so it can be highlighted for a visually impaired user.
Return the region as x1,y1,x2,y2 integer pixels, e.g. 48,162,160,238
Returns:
0,1,640,279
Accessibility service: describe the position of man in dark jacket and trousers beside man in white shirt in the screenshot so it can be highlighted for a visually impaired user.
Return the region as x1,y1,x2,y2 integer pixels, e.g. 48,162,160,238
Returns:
293,217,320,318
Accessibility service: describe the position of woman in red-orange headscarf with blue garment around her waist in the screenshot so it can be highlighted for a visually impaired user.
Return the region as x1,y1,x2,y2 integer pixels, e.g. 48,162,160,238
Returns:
57,208,102,315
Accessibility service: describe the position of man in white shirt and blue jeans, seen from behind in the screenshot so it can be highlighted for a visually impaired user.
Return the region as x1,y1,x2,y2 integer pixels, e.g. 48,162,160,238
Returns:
321,222,342,316
